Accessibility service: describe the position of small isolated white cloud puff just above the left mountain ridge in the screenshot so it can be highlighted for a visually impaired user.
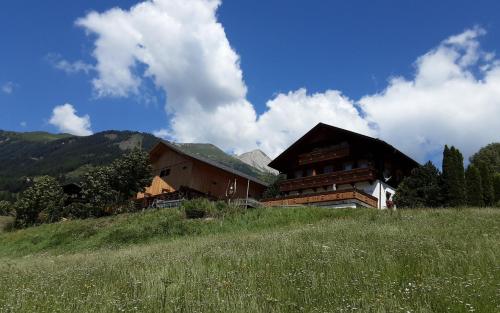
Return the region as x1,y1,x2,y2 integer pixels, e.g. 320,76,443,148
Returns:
49,103,92,136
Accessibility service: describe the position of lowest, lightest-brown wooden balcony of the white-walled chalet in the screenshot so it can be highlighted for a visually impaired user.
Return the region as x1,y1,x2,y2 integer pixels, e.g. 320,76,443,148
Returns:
262,189,378,208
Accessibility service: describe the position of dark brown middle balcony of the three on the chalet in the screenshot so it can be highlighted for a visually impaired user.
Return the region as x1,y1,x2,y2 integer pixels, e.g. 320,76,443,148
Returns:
280,167,376,192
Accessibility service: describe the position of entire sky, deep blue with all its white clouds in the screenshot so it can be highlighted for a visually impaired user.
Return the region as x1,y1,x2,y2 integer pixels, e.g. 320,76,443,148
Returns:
0,0,500,165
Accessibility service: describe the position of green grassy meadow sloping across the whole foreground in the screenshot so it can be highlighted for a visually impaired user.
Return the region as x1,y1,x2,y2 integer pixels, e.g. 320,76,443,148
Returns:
0,208,500,312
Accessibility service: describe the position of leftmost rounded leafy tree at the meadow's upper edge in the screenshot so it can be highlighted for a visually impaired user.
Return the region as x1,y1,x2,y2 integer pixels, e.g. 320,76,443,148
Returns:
14,176,65,227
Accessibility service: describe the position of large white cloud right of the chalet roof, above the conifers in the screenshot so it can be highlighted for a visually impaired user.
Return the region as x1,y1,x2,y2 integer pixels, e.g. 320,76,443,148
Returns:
359,28,500,161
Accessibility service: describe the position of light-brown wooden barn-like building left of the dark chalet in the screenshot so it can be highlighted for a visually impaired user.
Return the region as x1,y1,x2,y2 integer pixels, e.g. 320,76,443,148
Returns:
137,141,267,205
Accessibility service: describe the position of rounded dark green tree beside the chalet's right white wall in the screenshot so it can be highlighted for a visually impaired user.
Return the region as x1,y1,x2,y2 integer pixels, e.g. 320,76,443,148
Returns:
394,161,442,208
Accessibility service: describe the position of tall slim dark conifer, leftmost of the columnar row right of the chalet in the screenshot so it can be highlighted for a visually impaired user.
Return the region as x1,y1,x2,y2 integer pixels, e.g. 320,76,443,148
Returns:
443,146,465,207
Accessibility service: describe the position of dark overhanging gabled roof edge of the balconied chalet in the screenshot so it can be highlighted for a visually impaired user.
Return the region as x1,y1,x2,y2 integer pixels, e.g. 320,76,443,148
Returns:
268,123,420,169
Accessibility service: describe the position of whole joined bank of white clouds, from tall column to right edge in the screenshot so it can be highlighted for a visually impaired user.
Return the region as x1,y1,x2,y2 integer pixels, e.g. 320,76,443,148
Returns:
76,0,500,161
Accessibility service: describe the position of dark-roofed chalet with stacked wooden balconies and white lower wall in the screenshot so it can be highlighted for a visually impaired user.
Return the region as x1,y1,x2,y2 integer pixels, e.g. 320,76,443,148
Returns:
265,123,419,208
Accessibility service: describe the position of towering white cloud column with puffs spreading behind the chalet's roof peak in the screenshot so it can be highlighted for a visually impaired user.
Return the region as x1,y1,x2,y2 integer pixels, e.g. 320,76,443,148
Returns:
77,0,369,155
